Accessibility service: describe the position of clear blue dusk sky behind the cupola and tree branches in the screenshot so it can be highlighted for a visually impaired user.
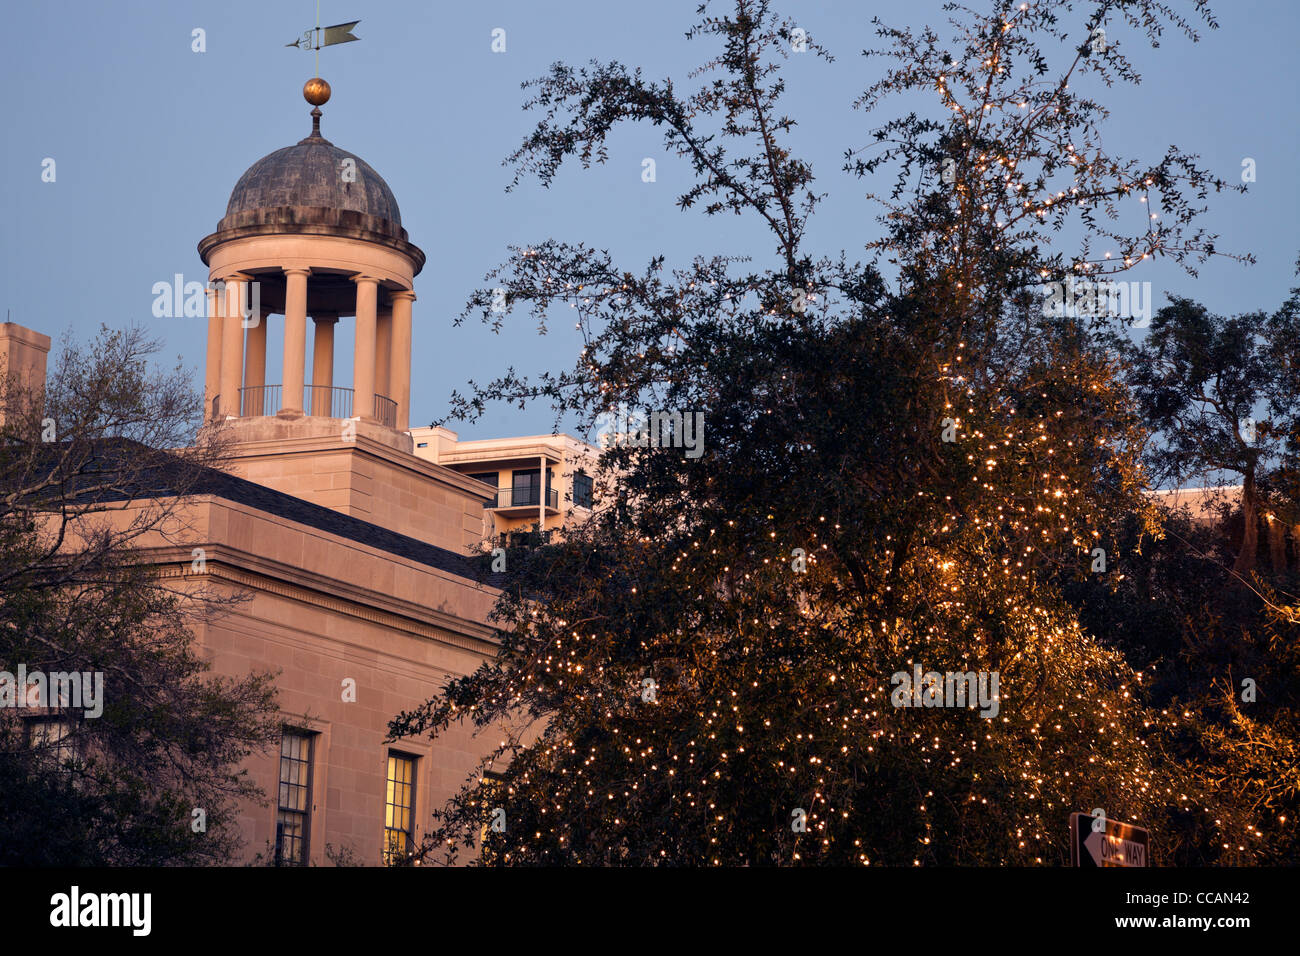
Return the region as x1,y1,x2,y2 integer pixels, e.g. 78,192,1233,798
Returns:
0,0,1300,437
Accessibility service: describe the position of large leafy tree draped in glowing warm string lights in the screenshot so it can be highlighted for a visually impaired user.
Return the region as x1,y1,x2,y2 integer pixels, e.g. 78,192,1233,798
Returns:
390,0,1268,865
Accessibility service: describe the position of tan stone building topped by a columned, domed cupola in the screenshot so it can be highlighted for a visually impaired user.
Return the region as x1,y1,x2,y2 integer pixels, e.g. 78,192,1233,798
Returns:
185,82,495,865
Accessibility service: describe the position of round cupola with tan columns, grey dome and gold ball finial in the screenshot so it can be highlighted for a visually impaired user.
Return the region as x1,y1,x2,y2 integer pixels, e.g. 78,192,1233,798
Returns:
199,78,425,444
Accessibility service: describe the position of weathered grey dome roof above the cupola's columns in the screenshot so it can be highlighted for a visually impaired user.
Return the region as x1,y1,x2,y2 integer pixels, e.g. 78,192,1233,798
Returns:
226,130,402,226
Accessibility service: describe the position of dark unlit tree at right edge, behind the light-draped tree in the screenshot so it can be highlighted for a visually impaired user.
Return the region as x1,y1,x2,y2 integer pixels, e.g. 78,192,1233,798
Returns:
1073,270,1300,864
